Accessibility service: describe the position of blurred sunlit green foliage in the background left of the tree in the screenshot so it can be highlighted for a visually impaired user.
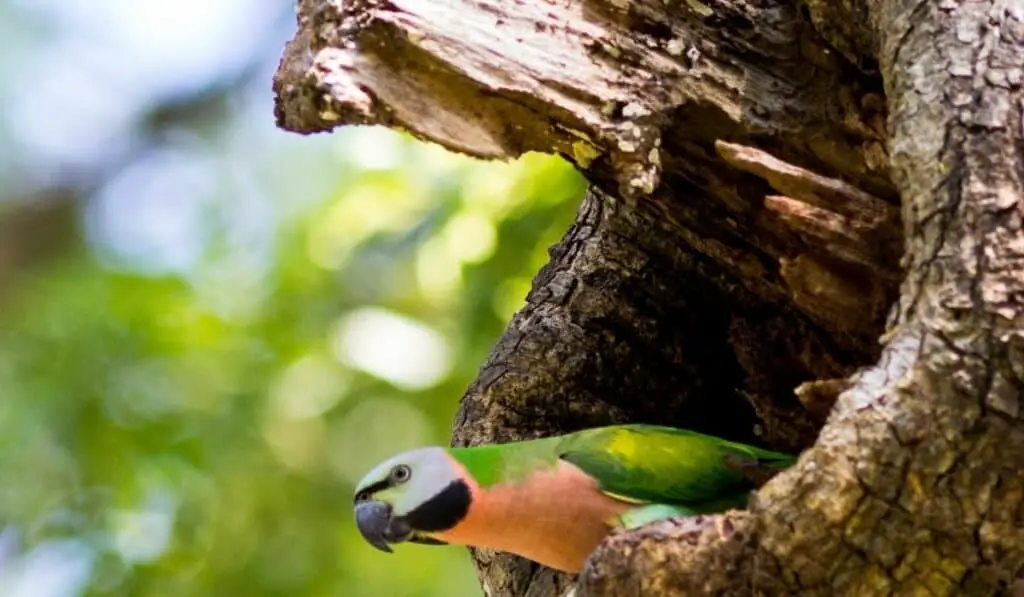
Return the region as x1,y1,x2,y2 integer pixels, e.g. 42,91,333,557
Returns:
0,0,583,597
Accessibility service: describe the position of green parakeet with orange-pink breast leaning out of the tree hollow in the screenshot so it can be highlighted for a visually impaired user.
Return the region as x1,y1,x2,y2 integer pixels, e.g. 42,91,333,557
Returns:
354,425,795,572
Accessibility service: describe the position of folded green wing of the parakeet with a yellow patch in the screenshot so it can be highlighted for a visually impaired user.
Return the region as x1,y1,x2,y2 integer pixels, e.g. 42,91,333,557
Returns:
559,425,795,511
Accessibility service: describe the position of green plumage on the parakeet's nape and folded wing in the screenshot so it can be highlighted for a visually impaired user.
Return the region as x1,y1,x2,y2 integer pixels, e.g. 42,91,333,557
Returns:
451,425,795,513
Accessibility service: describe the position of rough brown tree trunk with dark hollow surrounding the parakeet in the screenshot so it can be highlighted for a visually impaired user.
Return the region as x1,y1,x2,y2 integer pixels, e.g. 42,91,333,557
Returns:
274,0,1024,596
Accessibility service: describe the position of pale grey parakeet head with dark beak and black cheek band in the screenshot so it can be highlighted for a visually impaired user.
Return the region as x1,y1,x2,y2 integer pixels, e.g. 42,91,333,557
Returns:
354,447,472,552
